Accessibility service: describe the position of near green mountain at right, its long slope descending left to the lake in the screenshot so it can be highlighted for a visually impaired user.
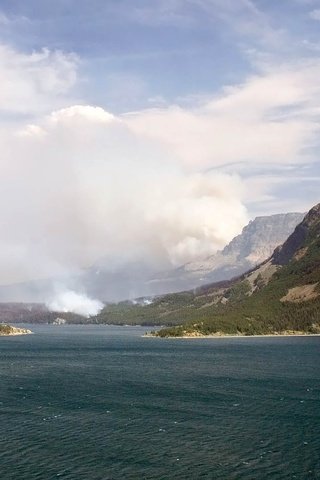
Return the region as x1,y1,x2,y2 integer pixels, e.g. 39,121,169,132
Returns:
98,204,320,336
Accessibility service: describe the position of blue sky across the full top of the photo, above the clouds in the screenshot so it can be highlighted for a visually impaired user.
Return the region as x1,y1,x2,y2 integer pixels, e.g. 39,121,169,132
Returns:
0,0,320,112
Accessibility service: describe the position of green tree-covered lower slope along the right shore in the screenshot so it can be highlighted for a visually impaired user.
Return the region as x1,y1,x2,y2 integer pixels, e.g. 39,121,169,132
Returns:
153,242,320,336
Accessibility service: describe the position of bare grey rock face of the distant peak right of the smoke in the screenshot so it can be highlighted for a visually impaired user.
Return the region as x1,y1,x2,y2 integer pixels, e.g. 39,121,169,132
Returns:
150,213,304,291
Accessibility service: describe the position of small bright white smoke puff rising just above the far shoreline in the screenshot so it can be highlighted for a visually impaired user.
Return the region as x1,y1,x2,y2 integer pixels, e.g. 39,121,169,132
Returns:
47,290,104,317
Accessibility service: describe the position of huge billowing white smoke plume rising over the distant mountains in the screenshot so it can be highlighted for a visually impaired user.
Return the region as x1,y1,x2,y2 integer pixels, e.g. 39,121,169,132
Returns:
0,106,248,288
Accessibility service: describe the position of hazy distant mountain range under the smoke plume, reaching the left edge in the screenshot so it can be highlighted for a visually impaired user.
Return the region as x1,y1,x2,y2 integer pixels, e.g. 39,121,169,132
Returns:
0,213,304,303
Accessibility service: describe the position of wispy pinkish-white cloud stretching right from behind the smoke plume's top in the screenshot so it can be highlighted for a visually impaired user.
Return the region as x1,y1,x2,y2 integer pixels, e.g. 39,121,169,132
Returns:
124,60,320,169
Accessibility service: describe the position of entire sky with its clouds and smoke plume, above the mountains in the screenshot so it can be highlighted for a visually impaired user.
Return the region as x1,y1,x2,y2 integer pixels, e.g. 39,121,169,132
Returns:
0,0,320,284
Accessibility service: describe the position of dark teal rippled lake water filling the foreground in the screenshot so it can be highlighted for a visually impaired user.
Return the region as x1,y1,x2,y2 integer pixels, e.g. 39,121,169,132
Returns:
0,326,320,480
